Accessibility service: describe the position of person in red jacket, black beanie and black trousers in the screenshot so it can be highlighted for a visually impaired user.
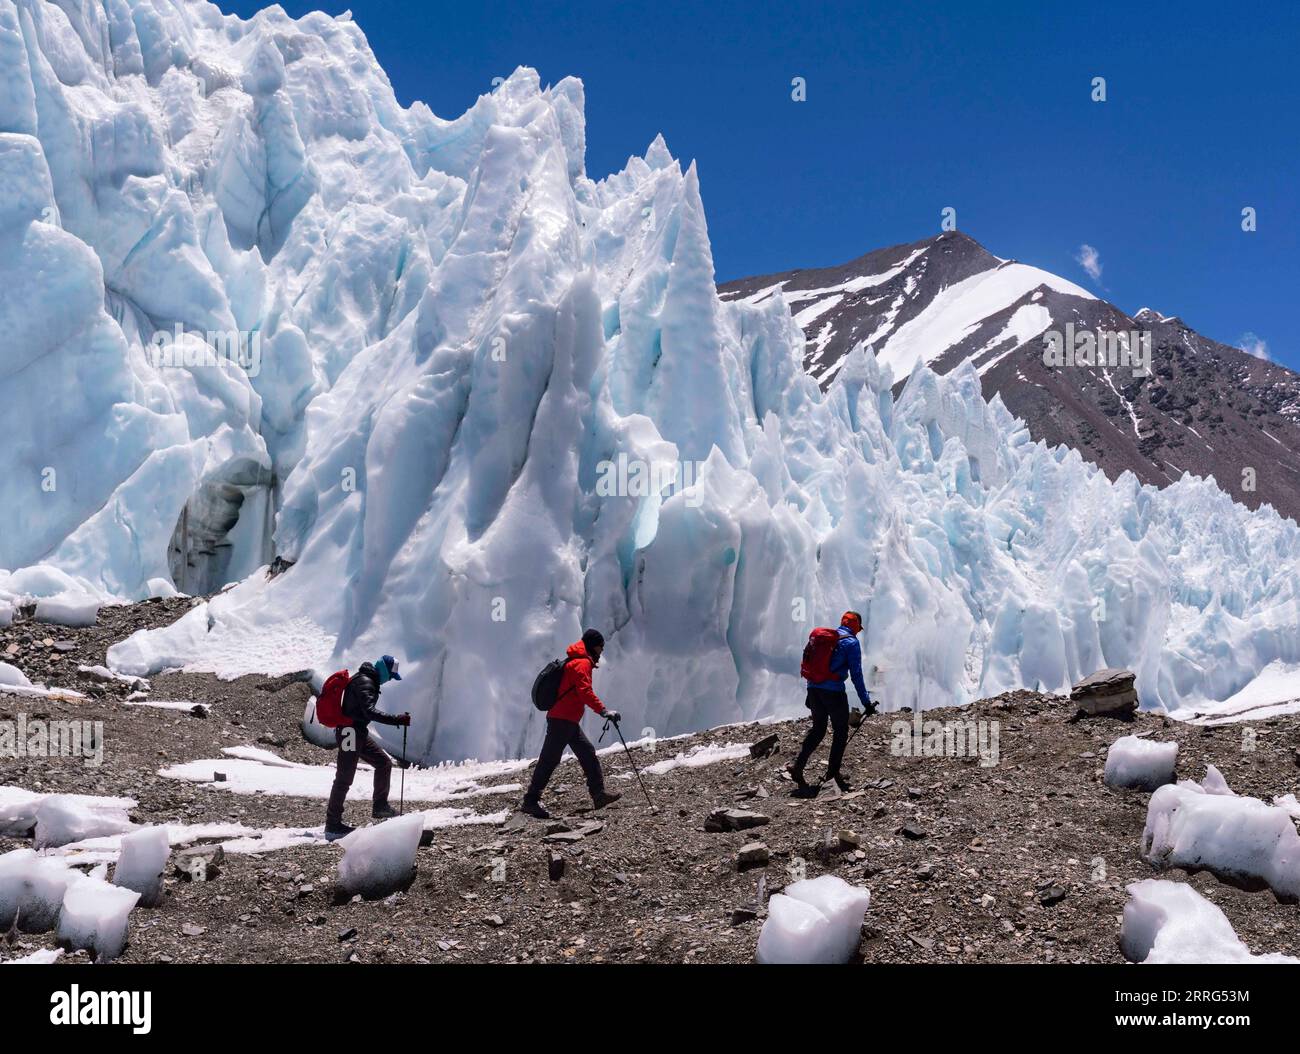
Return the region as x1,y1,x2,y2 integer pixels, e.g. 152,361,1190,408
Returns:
520,629,623,820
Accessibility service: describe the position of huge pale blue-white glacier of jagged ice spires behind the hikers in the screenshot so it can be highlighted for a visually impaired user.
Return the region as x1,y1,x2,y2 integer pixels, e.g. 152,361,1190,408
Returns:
0,0,1300,762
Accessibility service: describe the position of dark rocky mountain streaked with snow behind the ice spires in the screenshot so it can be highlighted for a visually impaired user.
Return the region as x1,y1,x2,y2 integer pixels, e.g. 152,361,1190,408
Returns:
720,231,1300,519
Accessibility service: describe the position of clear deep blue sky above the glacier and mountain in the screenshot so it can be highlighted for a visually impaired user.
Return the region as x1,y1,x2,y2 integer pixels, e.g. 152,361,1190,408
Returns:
228,0,1300,369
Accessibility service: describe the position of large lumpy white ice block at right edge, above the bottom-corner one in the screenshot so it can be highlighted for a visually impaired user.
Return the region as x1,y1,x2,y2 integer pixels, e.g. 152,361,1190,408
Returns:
1141,780,1300,901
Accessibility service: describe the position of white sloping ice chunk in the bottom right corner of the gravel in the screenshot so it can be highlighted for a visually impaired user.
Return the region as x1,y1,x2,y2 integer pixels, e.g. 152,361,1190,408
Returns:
1119,879,1300,963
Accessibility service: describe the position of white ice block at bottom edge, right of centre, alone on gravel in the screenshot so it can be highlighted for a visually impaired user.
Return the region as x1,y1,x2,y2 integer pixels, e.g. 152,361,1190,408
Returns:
758,875,871,963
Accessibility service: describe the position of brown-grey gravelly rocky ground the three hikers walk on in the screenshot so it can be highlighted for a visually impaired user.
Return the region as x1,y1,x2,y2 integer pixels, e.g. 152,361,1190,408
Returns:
0,599,1300,963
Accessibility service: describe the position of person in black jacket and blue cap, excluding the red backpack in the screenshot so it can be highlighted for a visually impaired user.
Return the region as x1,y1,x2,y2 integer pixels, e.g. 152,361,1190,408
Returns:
325,655,411,842
